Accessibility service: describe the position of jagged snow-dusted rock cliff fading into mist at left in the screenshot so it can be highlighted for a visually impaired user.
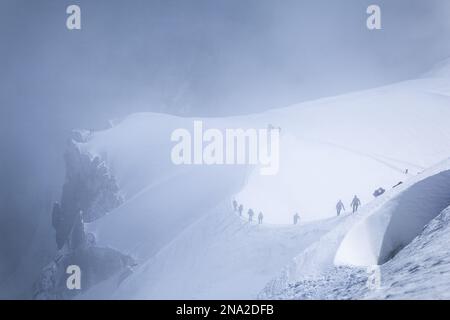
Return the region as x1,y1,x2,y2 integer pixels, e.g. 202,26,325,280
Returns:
33,132,135,299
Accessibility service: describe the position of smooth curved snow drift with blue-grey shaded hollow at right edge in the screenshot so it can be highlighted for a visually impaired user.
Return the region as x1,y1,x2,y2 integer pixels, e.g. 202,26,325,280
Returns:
335,161,450,266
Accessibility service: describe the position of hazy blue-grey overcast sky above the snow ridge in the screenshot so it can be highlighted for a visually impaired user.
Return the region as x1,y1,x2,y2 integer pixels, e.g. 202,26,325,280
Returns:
0,0,450,296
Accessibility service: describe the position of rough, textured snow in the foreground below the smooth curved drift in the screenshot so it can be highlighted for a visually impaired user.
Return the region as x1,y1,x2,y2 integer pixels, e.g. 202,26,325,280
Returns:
263,200,450,300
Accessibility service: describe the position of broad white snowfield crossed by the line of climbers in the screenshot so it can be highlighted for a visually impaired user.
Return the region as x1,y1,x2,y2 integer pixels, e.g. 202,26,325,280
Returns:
79,58,450,299
